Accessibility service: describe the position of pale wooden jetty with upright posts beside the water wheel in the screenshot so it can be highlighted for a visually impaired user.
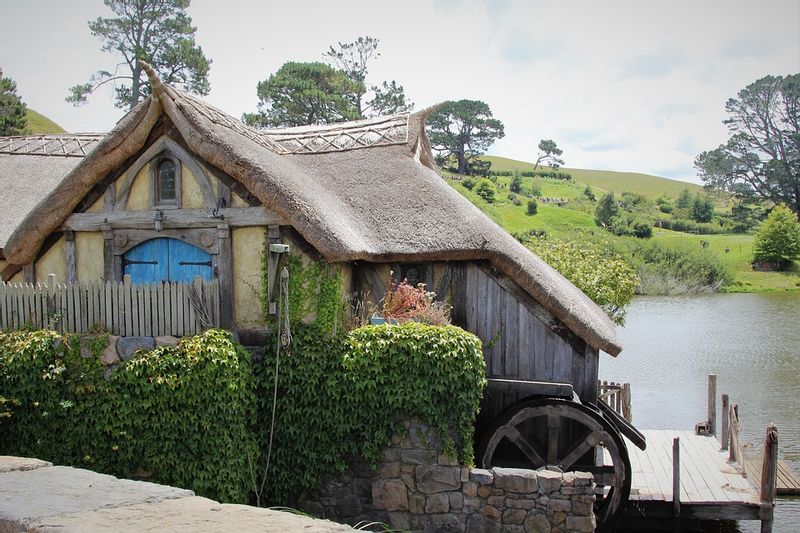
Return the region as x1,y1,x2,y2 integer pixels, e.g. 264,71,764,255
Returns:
615,375,800,533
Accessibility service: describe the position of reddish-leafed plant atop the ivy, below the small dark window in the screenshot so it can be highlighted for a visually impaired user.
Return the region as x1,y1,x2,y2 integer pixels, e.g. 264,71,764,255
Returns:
383,280,450,326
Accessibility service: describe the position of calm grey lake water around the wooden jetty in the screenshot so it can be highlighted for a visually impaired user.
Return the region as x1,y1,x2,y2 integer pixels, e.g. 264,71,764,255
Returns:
600,293,800,533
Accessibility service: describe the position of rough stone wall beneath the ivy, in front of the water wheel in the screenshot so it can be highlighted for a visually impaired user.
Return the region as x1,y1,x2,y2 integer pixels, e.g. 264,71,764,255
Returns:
301,422,595,533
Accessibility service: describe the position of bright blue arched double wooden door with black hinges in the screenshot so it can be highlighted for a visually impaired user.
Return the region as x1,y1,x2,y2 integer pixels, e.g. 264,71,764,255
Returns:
122,237,212,283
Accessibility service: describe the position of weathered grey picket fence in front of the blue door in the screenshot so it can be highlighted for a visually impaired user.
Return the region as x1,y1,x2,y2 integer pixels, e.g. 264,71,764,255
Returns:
0,274,220,337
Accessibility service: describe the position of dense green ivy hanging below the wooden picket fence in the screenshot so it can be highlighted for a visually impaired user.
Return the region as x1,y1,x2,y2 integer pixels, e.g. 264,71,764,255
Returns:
0,330,257,503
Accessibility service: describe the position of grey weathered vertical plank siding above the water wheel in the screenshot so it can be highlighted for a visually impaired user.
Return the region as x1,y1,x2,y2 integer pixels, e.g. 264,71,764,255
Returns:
353,261,598,408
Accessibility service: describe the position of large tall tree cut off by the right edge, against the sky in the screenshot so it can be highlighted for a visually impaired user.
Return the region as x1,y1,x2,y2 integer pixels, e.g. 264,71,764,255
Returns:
695,74,800,216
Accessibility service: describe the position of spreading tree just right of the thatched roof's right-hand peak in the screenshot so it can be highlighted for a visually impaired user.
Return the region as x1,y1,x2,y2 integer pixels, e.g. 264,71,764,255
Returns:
428,100,505,174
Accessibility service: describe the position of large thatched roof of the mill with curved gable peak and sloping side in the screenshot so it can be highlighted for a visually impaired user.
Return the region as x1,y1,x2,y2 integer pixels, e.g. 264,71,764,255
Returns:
0,61,621,355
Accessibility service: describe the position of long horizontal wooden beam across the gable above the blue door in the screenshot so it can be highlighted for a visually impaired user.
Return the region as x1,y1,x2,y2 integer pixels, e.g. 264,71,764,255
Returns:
62,207,283,231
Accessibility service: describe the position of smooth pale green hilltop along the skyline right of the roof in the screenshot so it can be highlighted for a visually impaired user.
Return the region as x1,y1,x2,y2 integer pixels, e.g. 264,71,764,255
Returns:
483,155,704,199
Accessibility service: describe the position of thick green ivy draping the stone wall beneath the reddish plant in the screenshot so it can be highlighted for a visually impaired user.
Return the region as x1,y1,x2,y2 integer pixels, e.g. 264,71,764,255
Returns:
257,322,486,504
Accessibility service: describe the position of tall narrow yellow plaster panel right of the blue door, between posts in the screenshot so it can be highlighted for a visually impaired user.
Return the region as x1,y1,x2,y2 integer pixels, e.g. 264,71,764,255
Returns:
231,227,266,329
